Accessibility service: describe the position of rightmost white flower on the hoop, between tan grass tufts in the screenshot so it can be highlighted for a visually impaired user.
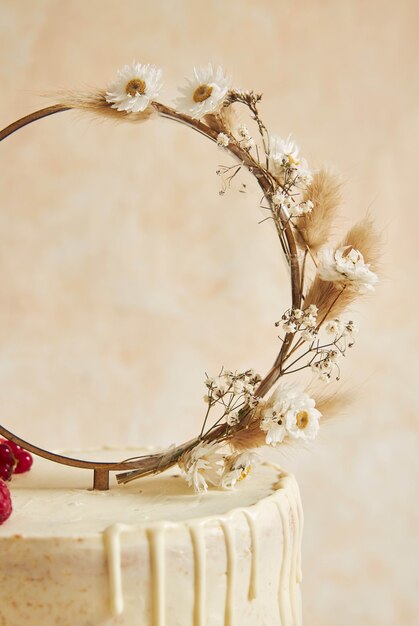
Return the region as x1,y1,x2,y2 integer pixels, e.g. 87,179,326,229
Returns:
318,246,378,291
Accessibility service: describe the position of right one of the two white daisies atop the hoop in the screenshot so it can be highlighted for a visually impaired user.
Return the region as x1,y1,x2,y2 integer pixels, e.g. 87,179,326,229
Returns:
176,64,231,119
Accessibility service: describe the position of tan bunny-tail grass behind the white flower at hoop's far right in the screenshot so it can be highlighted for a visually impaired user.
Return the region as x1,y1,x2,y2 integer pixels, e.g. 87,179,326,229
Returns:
304,217,381,323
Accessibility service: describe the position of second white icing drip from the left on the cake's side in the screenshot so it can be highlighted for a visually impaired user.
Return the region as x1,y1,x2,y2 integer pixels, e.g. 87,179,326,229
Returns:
147,524,166,626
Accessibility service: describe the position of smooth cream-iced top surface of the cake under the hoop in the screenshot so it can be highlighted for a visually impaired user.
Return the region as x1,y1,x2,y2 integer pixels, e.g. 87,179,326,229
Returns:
0,448,284,538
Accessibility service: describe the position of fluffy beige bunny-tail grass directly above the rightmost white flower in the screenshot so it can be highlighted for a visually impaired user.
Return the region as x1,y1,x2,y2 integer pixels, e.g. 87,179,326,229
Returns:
295,169,342,254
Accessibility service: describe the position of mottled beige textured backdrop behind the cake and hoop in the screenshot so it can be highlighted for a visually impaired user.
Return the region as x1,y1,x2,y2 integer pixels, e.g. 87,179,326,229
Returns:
0,0,419,626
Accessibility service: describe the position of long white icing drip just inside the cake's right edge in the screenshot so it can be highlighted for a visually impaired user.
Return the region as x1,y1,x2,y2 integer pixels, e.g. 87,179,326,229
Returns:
276,493,293,626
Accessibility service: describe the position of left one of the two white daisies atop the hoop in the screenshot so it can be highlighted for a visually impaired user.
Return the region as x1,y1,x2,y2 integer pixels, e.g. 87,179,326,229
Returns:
105,63,162,113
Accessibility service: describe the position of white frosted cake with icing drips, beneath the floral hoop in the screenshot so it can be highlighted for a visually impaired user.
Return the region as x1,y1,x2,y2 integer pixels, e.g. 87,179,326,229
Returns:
0,450,302,626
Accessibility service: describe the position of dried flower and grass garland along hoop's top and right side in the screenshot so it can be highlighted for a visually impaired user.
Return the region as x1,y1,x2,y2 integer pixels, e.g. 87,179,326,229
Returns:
0,63,379,491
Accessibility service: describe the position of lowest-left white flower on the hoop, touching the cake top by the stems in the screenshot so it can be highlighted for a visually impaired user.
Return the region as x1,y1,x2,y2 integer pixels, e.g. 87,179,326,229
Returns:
179,443,224,492
